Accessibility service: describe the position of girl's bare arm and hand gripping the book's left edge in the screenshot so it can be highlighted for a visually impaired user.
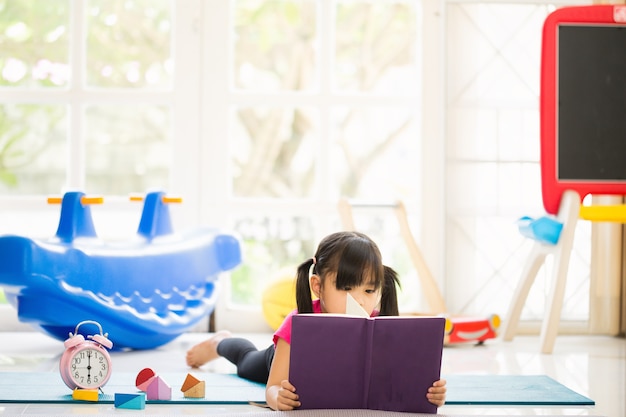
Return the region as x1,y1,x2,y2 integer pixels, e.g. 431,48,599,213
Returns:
265,339,300,410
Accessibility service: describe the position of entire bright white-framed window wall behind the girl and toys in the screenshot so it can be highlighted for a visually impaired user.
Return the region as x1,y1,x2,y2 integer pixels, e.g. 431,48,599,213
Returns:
0,0,586,331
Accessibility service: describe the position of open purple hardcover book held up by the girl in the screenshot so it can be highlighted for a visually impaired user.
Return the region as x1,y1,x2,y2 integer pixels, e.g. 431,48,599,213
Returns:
289,314,445,414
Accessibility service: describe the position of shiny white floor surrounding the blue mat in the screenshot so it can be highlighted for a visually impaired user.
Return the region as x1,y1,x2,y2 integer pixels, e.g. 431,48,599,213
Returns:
0,332,626,417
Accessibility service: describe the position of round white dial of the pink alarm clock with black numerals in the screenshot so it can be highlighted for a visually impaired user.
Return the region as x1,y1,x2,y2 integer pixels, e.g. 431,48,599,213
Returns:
66,347,111,389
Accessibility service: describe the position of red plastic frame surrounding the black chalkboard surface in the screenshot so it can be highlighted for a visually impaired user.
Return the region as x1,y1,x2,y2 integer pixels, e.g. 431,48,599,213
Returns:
540,5,626,214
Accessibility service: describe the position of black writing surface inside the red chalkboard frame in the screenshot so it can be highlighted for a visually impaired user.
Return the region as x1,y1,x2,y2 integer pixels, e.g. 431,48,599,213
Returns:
556,24,626,181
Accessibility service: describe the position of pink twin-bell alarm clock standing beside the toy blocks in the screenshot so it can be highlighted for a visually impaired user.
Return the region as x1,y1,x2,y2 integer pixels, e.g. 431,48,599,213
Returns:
59,320,113,390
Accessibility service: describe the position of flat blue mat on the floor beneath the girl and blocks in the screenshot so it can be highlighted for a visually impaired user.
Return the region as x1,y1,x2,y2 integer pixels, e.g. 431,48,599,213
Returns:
0,372,595,406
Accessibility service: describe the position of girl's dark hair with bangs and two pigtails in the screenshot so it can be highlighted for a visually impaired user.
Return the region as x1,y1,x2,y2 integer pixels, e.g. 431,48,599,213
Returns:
296,232,399,316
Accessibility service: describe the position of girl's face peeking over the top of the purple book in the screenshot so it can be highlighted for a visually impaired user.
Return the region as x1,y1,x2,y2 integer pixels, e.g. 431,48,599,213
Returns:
311,275,380,316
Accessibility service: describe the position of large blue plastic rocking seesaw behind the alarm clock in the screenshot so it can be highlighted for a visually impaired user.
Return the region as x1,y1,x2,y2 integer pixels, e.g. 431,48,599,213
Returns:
0,192,241,349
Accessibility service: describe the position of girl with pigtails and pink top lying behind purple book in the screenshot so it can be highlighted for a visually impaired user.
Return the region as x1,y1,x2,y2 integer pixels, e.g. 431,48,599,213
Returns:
186,232,446,410
